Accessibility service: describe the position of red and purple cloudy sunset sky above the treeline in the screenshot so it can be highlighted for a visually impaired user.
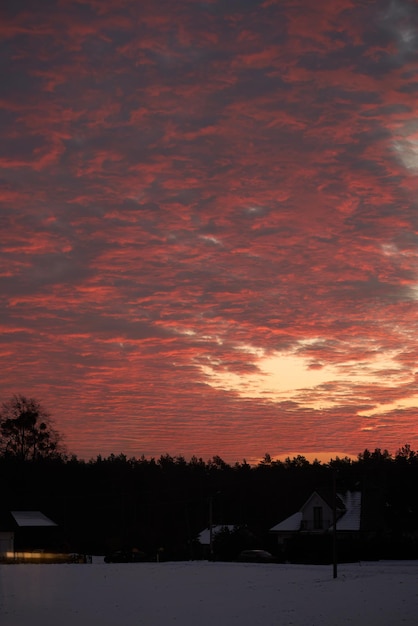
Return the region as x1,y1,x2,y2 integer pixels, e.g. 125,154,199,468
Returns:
0,0,418,462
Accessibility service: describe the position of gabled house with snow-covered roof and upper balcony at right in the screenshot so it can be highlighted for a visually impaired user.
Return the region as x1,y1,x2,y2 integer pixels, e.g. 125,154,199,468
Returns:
270,491,362,561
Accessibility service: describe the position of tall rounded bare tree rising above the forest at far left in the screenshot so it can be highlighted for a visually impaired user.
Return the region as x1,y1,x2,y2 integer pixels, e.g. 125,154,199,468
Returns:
0,395,64,461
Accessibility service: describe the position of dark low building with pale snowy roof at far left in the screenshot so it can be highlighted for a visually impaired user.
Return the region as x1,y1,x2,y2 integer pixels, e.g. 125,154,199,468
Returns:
0,511,58,558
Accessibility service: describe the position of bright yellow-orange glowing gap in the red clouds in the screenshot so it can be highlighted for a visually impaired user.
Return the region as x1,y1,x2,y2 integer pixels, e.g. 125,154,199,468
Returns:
200,340,418,416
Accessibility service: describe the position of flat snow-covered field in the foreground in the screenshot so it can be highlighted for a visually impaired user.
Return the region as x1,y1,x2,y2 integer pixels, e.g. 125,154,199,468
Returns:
0,561,418,626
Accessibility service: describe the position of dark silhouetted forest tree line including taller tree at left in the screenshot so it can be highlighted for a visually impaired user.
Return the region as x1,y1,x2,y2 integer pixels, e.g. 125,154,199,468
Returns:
0,396,418,559
